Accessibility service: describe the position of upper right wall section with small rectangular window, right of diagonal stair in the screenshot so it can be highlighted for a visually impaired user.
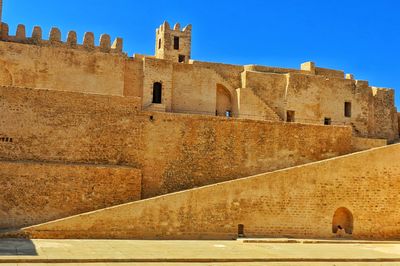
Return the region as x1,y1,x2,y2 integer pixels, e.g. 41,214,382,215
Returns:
287,74,373,132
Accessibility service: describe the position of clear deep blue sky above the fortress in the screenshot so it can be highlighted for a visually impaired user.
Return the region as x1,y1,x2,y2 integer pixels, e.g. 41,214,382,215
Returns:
3,0,400,107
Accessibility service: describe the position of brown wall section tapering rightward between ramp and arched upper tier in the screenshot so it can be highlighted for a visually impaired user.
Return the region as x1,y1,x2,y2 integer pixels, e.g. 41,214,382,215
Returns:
142,114,351,198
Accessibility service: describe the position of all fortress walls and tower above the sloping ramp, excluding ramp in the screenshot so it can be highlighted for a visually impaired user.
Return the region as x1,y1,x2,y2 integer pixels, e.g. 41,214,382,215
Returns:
0,3,399,239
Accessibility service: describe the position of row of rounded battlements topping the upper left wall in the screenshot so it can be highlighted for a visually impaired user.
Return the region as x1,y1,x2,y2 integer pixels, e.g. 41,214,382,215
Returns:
0,23,123,54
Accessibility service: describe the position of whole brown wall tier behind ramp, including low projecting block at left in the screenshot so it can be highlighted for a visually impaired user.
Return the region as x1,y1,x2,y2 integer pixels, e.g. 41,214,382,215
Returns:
0,87,352,228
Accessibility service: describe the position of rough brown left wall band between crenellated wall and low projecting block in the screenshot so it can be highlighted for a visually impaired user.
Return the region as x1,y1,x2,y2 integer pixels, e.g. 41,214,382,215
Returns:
0,87,141,166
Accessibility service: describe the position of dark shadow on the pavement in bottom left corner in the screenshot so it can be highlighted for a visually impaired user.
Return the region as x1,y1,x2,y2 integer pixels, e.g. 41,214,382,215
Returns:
0,239,38,256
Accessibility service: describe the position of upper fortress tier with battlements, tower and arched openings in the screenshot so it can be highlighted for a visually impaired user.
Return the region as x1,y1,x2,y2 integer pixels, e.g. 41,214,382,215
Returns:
0,20,398,142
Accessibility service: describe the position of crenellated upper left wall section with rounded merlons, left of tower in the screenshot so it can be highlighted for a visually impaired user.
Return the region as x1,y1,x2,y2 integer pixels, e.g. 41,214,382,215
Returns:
0,23,125,95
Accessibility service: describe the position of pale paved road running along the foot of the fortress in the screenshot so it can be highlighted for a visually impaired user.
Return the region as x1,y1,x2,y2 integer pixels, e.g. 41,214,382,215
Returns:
0,240,400,266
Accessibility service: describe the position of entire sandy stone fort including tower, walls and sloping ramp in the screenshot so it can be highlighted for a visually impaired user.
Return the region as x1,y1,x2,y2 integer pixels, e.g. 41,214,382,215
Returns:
0,0,400,240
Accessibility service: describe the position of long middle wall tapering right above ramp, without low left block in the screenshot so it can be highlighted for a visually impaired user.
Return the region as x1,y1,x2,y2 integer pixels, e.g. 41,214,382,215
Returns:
0,87,351,198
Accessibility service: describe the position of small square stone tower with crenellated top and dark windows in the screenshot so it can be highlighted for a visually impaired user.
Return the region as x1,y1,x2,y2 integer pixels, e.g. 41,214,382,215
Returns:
156,22,192,63
